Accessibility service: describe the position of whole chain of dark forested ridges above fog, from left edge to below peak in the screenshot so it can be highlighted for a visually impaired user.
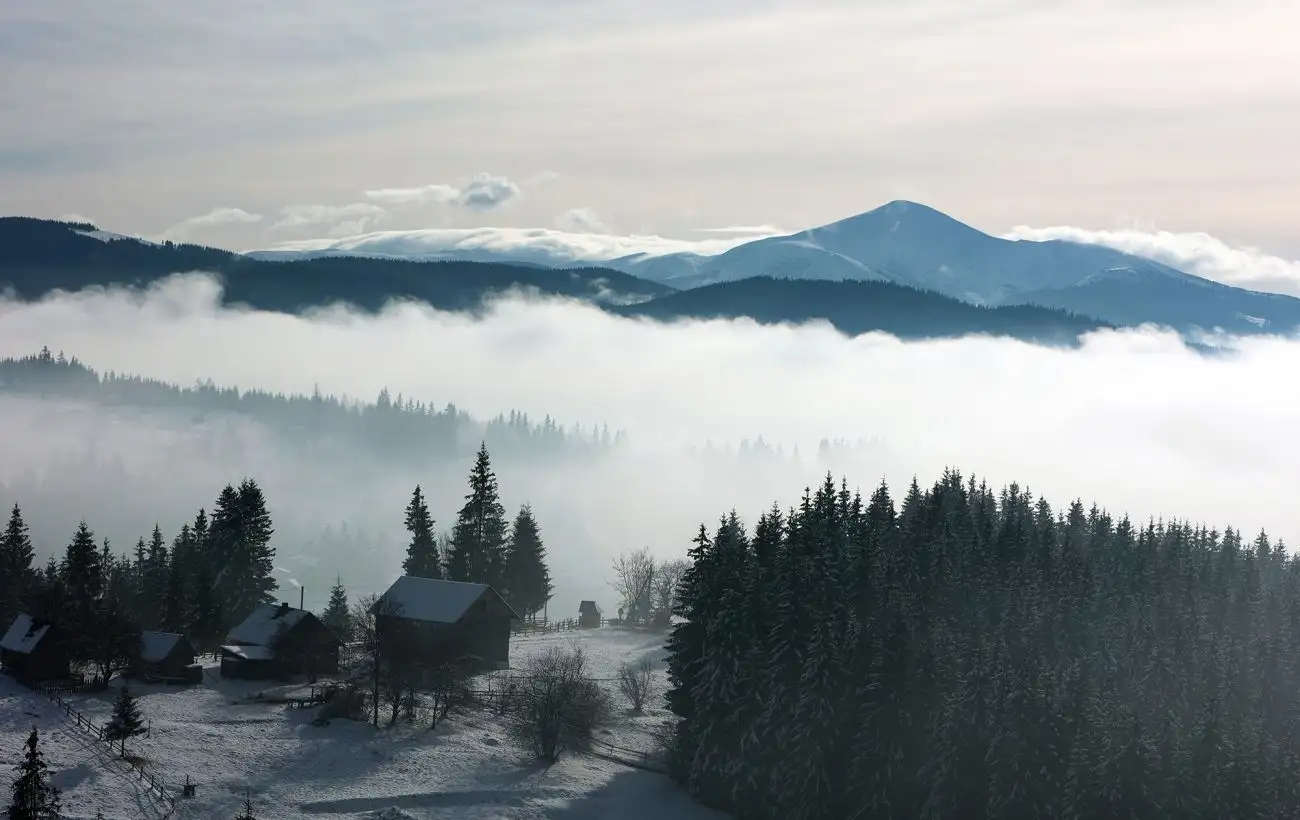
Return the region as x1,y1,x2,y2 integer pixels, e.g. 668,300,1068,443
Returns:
0,217,1108,344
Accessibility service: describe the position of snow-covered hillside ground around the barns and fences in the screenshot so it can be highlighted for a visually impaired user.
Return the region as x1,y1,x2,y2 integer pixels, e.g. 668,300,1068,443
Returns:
0,629,722,820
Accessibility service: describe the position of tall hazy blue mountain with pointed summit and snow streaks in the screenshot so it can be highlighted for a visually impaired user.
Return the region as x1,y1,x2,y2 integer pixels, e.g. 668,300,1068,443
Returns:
610,201,1300,334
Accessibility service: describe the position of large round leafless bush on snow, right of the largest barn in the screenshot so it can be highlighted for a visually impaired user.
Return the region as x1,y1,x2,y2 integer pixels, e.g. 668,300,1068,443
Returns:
506,643,610,763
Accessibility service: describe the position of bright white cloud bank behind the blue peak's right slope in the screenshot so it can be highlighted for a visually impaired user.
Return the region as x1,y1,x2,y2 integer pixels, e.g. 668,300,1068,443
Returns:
1006,225,1300,296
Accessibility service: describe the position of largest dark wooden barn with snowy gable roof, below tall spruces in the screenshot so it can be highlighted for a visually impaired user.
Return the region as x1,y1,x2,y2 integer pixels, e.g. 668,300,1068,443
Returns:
372,576,520,672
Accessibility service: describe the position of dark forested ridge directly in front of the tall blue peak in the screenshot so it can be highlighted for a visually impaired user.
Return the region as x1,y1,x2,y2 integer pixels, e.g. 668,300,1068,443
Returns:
608,277,1109,346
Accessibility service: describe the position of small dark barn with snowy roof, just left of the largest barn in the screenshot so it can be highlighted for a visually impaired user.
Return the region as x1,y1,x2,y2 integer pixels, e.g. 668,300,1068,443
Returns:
221,603,339,681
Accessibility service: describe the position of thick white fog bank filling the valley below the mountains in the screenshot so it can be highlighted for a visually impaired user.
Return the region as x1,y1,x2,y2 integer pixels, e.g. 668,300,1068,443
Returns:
0,277,1300,612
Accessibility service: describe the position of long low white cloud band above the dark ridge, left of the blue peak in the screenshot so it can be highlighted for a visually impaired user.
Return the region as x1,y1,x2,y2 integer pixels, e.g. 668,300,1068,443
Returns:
263,227,753,265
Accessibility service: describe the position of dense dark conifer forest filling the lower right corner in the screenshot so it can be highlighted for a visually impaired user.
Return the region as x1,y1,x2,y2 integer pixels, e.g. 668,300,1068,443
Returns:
668,472,1300,820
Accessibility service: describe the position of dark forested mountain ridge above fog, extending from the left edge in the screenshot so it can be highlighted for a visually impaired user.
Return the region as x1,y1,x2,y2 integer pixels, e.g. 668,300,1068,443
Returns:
0,217,673,312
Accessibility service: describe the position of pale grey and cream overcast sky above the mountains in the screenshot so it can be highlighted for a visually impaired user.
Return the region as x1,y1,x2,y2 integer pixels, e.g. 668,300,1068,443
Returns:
0,0,1300,269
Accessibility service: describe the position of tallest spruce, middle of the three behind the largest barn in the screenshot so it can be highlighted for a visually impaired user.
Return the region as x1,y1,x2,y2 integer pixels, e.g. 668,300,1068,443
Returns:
447,443,510,589
